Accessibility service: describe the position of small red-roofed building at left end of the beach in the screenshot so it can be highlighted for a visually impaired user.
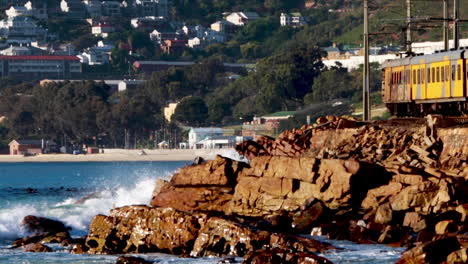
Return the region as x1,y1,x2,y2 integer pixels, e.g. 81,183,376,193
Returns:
8,139,57,155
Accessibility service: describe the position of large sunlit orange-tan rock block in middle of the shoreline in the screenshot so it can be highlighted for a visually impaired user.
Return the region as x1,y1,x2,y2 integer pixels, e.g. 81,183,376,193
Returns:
230,157,390,216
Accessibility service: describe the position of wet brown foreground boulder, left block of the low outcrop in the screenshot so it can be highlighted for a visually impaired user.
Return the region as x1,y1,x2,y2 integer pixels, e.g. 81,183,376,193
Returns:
86,205,206,255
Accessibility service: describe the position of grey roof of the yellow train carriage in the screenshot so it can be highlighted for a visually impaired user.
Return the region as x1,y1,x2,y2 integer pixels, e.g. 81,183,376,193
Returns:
382,49,465,68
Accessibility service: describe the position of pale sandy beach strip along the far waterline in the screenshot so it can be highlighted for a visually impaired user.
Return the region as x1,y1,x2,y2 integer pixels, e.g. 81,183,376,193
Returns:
0,149,238,163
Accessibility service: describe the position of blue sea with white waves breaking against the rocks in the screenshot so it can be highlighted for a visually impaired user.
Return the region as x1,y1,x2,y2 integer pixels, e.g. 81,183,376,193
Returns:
0,161,402,264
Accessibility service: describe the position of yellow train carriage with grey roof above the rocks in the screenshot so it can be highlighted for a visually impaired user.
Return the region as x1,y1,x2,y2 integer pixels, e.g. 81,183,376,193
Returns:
382,49,468,116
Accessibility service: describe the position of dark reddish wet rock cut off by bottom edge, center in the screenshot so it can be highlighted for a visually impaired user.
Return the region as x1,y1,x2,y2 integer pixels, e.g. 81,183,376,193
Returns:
243,248,332,264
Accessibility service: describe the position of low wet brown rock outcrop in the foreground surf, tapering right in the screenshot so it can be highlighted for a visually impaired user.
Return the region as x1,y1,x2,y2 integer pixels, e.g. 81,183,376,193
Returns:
86,206,335,263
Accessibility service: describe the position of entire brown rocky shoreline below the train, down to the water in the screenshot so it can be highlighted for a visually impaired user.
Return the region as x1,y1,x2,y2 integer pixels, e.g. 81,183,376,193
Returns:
11,116,468,264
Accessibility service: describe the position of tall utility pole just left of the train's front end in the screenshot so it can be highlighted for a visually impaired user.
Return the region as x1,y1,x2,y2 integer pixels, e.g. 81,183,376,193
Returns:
362,0,371,121
